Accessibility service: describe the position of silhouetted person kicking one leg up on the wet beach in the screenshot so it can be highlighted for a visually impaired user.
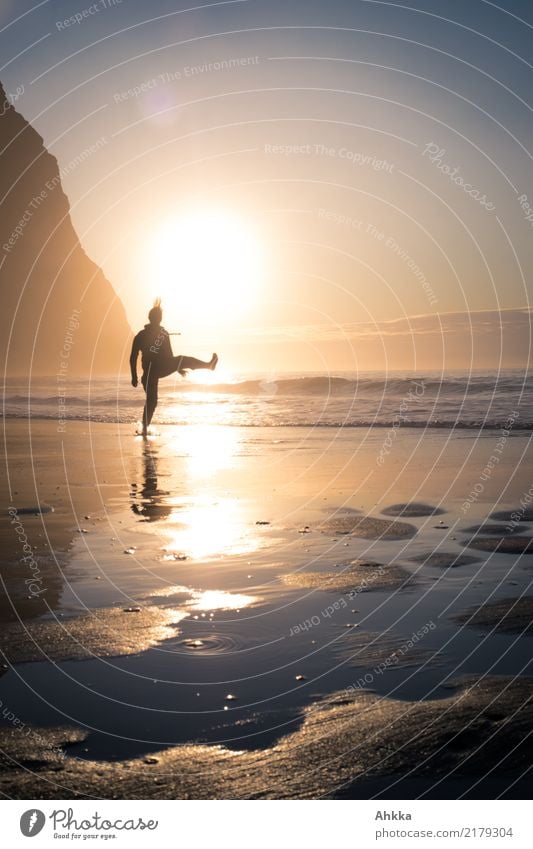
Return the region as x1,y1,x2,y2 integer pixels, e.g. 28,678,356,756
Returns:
130,299,218,436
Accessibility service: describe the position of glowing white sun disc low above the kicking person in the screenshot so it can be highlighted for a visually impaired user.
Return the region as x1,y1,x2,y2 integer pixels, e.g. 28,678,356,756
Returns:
147,209,264,325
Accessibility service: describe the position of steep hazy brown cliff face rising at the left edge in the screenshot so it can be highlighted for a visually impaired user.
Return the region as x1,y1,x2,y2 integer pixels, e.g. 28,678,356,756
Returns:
0,84,131,375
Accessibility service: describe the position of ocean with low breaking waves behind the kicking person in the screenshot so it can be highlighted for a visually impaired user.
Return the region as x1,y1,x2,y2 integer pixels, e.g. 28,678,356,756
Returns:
4,369,533,431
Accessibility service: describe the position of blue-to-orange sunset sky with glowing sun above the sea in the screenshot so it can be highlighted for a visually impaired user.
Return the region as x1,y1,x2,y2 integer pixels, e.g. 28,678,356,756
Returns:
0,0,533,371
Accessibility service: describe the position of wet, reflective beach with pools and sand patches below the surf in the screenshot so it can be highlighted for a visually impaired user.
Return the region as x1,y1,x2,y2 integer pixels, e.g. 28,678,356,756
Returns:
0,396,533,798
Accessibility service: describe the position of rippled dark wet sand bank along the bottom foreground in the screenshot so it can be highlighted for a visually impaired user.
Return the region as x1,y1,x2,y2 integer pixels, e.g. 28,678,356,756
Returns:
0,680,533,799
